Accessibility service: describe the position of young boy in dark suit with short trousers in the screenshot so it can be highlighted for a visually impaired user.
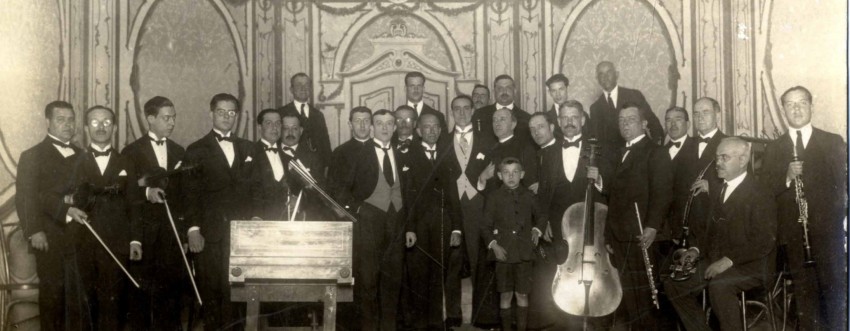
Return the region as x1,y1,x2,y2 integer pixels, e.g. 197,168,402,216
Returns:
481,157,548,330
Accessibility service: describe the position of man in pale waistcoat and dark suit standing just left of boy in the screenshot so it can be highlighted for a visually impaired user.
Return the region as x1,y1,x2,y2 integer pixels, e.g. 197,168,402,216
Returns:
444,95,499,324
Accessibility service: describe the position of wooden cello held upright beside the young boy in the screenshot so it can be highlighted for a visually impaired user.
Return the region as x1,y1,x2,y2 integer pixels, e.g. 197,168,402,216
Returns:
552,138,623,322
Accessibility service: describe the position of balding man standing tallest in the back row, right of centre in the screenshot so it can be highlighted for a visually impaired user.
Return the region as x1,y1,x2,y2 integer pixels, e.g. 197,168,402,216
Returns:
590,61,664,146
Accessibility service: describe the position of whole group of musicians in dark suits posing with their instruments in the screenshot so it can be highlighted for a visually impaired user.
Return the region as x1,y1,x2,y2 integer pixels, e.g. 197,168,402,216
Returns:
16,62,847,330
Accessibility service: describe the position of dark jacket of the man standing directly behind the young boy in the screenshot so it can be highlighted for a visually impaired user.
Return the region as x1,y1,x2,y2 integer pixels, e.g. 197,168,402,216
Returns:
484,135,538,193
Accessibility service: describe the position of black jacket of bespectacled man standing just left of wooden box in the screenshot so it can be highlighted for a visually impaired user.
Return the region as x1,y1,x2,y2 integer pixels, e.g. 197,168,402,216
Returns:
184,131,254,242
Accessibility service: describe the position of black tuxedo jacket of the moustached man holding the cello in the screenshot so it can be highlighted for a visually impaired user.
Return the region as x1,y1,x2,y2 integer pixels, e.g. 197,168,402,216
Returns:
537,139,613,240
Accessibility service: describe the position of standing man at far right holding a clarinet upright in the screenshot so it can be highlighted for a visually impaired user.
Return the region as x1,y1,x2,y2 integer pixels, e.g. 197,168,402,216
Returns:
762,86,847,330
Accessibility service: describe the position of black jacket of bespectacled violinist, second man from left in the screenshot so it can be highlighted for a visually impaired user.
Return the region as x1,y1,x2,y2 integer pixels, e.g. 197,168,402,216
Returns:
77,150,138,256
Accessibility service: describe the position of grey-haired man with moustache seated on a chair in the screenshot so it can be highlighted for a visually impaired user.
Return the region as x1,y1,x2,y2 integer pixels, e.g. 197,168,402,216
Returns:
664,137,777,331
